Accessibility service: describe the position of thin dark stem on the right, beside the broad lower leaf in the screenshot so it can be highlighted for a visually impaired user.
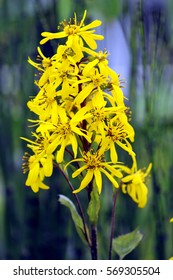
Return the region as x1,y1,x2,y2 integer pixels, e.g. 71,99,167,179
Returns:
109,188,120,260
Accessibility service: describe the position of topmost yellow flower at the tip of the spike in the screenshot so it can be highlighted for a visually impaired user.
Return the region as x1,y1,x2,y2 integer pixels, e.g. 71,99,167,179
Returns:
40,11,104,49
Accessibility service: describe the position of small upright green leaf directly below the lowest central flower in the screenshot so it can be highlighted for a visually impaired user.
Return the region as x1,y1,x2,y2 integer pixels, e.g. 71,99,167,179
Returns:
87,185,100,224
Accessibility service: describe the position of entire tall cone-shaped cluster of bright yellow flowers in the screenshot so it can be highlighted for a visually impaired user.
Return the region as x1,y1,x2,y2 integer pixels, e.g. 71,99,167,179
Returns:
23,11,151,207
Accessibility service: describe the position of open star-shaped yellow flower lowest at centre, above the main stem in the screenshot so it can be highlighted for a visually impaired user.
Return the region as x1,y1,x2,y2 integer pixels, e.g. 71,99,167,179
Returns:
66,148,122,194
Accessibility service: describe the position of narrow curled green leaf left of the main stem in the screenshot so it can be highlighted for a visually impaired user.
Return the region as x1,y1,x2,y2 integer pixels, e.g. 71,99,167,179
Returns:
58,194,89,244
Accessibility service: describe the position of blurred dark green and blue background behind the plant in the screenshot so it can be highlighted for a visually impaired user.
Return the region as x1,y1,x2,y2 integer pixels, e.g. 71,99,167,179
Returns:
0,0,173,259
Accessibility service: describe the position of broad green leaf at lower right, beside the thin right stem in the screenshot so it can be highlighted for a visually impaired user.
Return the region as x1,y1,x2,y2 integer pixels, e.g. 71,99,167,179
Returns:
112,229,143,259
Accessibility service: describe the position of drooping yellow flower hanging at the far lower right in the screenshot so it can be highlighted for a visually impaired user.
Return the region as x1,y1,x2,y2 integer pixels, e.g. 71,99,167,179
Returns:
121,163,152,208
